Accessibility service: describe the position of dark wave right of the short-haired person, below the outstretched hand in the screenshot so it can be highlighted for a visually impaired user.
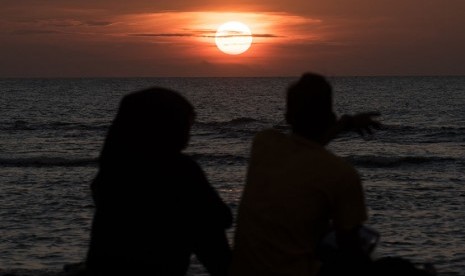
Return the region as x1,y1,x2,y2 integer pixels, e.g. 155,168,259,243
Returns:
345,155,459,168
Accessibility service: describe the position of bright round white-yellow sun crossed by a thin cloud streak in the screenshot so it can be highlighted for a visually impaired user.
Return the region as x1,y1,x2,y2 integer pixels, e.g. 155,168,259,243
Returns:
215,21,252,55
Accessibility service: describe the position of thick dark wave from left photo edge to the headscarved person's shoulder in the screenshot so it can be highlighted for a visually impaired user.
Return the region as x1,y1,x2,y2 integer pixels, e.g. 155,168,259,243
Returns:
0,157,97,167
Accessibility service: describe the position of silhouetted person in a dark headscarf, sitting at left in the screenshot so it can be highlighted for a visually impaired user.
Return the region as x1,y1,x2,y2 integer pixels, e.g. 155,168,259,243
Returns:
86,88,232,276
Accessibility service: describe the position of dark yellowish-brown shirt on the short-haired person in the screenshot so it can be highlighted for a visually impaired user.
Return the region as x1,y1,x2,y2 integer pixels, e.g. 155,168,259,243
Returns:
231,129,367,276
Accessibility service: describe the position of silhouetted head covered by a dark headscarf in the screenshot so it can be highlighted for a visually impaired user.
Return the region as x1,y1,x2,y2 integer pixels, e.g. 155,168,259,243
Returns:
101,87,195,166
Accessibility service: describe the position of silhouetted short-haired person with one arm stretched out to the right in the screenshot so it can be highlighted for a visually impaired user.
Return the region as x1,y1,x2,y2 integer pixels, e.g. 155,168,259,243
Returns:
230,73,379,276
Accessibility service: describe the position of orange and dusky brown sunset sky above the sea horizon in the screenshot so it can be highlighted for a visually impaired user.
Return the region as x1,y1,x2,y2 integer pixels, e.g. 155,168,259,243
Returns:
0,0,465,77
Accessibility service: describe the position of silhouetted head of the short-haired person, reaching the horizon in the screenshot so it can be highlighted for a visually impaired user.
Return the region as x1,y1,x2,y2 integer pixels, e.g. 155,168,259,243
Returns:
286,73,336,139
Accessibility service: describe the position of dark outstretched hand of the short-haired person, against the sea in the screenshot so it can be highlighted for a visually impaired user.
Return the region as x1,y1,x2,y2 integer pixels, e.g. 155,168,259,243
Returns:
338,111,381,137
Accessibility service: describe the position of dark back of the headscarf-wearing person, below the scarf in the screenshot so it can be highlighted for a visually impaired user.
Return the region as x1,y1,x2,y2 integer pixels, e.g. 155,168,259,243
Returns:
87,154,231,275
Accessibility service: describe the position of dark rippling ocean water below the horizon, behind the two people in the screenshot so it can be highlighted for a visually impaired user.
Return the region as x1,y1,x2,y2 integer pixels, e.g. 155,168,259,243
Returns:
0,77,465,276
